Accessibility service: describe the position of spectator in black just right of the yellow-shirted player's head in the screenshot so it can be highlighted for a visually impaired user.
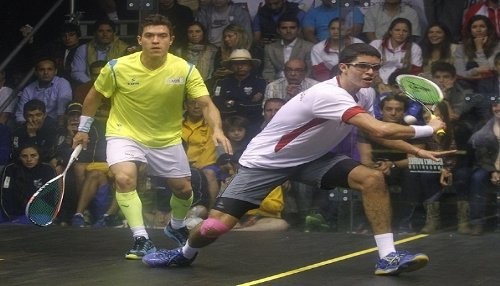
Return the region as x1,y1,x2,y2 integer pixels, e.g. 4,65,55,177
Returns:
158,0,194,51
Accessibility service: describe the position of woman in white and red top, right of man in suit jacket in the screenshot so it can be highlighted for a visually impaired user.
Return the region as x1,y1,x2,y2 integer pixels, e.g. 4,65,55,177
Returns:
311,18,363,81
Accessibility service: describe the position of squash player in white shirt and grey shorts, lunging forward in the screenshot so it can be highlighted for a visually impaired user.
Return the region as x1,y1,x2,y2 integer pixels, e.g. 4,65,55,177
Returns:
143,43,452,275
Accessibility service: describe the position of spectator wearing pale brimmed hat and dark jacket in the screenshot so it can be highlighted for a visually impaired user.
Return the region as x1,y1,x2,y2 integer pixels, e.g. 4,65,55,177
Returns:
213,49,266,137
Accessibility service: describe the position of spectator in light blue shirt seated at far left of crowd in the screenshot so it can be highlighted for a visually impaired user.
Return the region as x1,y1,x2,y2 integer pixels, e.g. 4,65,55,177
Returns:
16,58,73,126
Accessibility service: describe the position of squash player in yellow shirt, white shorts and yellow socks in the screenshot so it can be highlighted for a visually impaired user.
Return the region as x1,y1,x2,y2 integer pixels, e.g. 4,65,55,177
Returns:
73,14,232,259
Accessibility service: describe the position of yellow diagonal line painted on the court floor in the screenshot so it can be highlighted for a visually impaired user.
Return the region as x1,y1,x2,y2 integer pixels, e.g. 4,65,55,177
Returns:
237,234,428,286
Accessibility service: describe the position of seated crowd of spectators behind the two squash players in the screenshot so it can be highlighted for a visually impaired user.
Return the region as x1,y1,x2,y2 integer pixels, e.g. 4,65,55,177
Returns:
0,0,500,235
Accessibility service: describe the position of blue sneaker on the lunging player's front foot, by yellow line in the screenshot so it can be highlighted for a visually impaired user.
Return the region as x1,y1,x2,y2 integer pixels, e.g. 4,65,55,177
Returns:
375,251,429,276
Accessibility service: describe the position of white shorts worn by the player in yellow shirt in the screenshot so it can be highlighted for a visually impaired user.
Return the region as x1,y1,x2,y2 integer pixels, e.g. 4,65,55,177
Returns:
106,137,191,178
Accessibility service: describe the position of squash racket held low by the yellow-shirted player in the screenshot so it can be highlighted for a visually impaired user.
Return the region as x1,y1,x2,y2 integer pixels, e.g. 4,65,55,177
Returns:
26,145,82,226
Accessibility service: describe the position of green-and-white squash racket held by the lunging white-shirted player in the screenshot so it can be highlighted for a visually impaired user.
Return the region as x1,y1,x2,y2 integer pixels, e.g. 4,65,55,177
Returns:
396,74,446,136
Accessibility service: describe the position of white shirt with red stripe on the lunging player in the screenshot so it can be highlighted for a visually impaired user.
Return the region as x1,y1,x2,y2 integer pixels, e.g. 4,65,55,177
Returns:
239,77,375,169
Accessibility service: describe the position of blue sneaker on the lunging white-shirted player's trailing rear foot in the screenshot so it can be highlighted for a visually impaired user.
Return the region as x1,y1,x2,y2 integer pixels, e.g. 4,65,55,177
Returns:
142,247,198,267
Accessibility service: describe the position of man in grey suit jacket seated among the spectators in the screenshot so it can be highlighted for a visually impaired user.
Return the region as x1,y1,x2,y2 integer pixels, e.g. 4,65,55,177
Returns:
262,16,314,81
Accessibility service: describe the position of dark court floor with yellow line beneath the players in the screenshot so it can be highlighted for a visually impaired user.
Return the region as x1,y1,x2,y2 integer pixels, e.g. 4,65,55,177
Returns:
0,224,500,286
